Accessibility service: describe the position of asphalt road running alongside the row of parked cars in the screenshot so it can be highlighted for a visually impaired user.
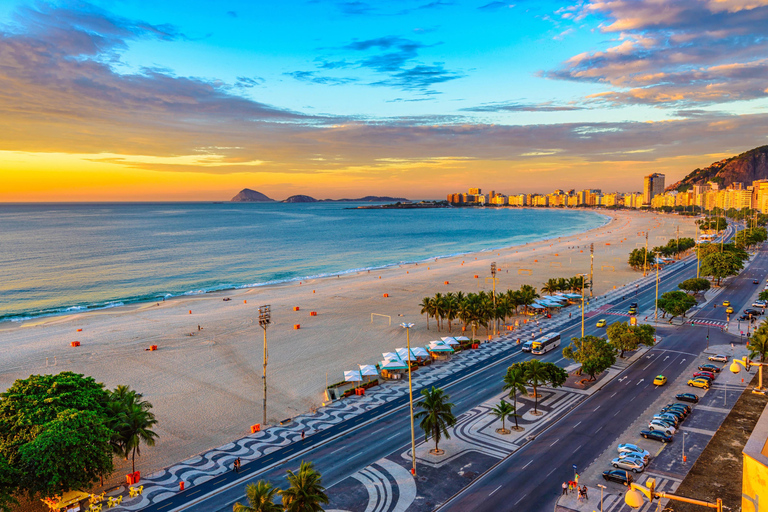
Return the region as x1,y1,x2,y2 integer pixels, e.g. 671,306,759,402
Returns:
439,241,768,512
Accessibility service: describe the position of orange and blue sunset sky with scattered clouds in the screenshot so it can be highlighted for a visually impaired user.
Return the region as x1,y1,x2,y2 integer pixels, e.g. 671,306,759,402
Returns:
0,0,768,202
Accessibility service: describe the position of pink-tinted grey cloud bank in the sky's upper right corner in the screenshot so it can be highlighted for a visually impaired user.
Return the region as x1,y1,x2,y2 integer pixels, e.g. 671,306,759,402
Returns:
542,0,768,108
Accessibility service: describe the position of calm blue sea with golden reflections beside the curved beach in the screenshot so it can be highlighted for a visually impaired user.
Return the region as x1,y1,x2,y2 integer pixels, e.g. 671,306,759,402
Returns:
0,203,607,321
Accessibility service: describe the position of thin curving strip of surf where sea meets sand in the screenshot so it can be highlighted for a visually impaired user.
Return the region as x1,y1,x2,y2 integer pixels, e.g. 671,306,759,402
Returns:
0,207,614,324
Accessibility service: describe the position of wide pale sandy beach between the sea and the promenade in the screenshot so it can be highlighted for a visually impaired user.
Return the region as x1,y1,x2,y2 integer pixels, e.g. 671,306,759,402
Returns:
0,211,695,483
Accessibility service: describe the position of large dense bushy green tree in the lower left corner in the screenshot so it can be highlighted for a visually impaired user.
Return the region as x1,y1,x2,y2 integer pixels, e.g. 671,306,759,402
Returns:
0,372,114,498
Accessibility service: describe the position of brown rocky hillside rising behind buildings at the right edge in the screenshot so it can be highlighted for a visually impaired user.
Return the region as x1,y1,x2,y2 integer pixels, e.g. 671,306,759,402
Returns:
667,146,768,192
